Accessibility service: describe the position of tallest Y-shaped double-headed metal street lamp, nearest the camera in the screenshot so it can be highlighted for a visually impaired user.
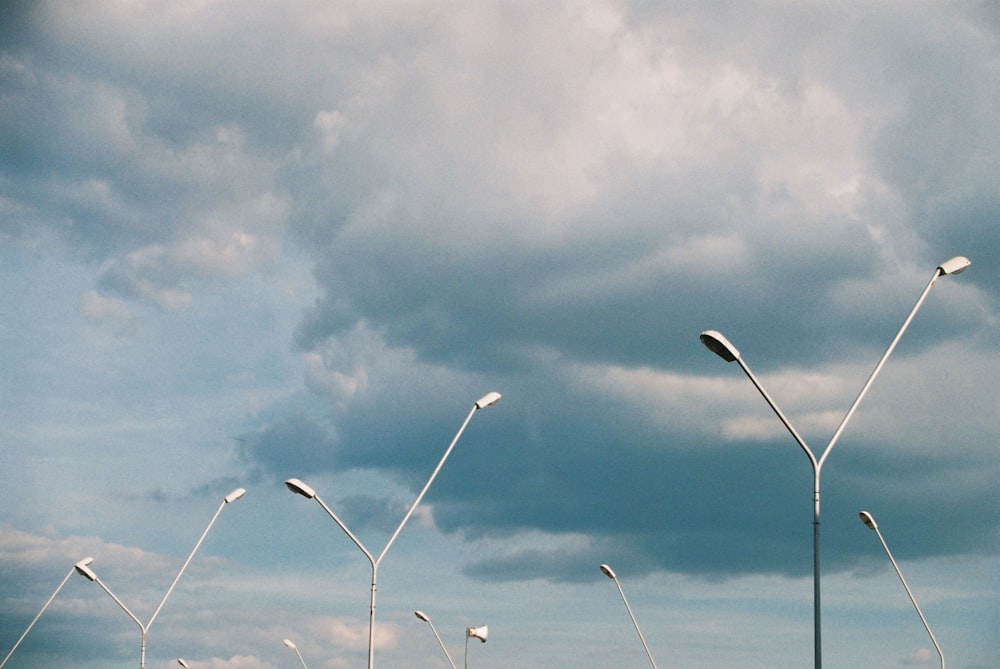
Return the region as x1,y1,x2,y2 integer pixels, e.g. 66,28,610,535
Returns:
701,256,971,669
